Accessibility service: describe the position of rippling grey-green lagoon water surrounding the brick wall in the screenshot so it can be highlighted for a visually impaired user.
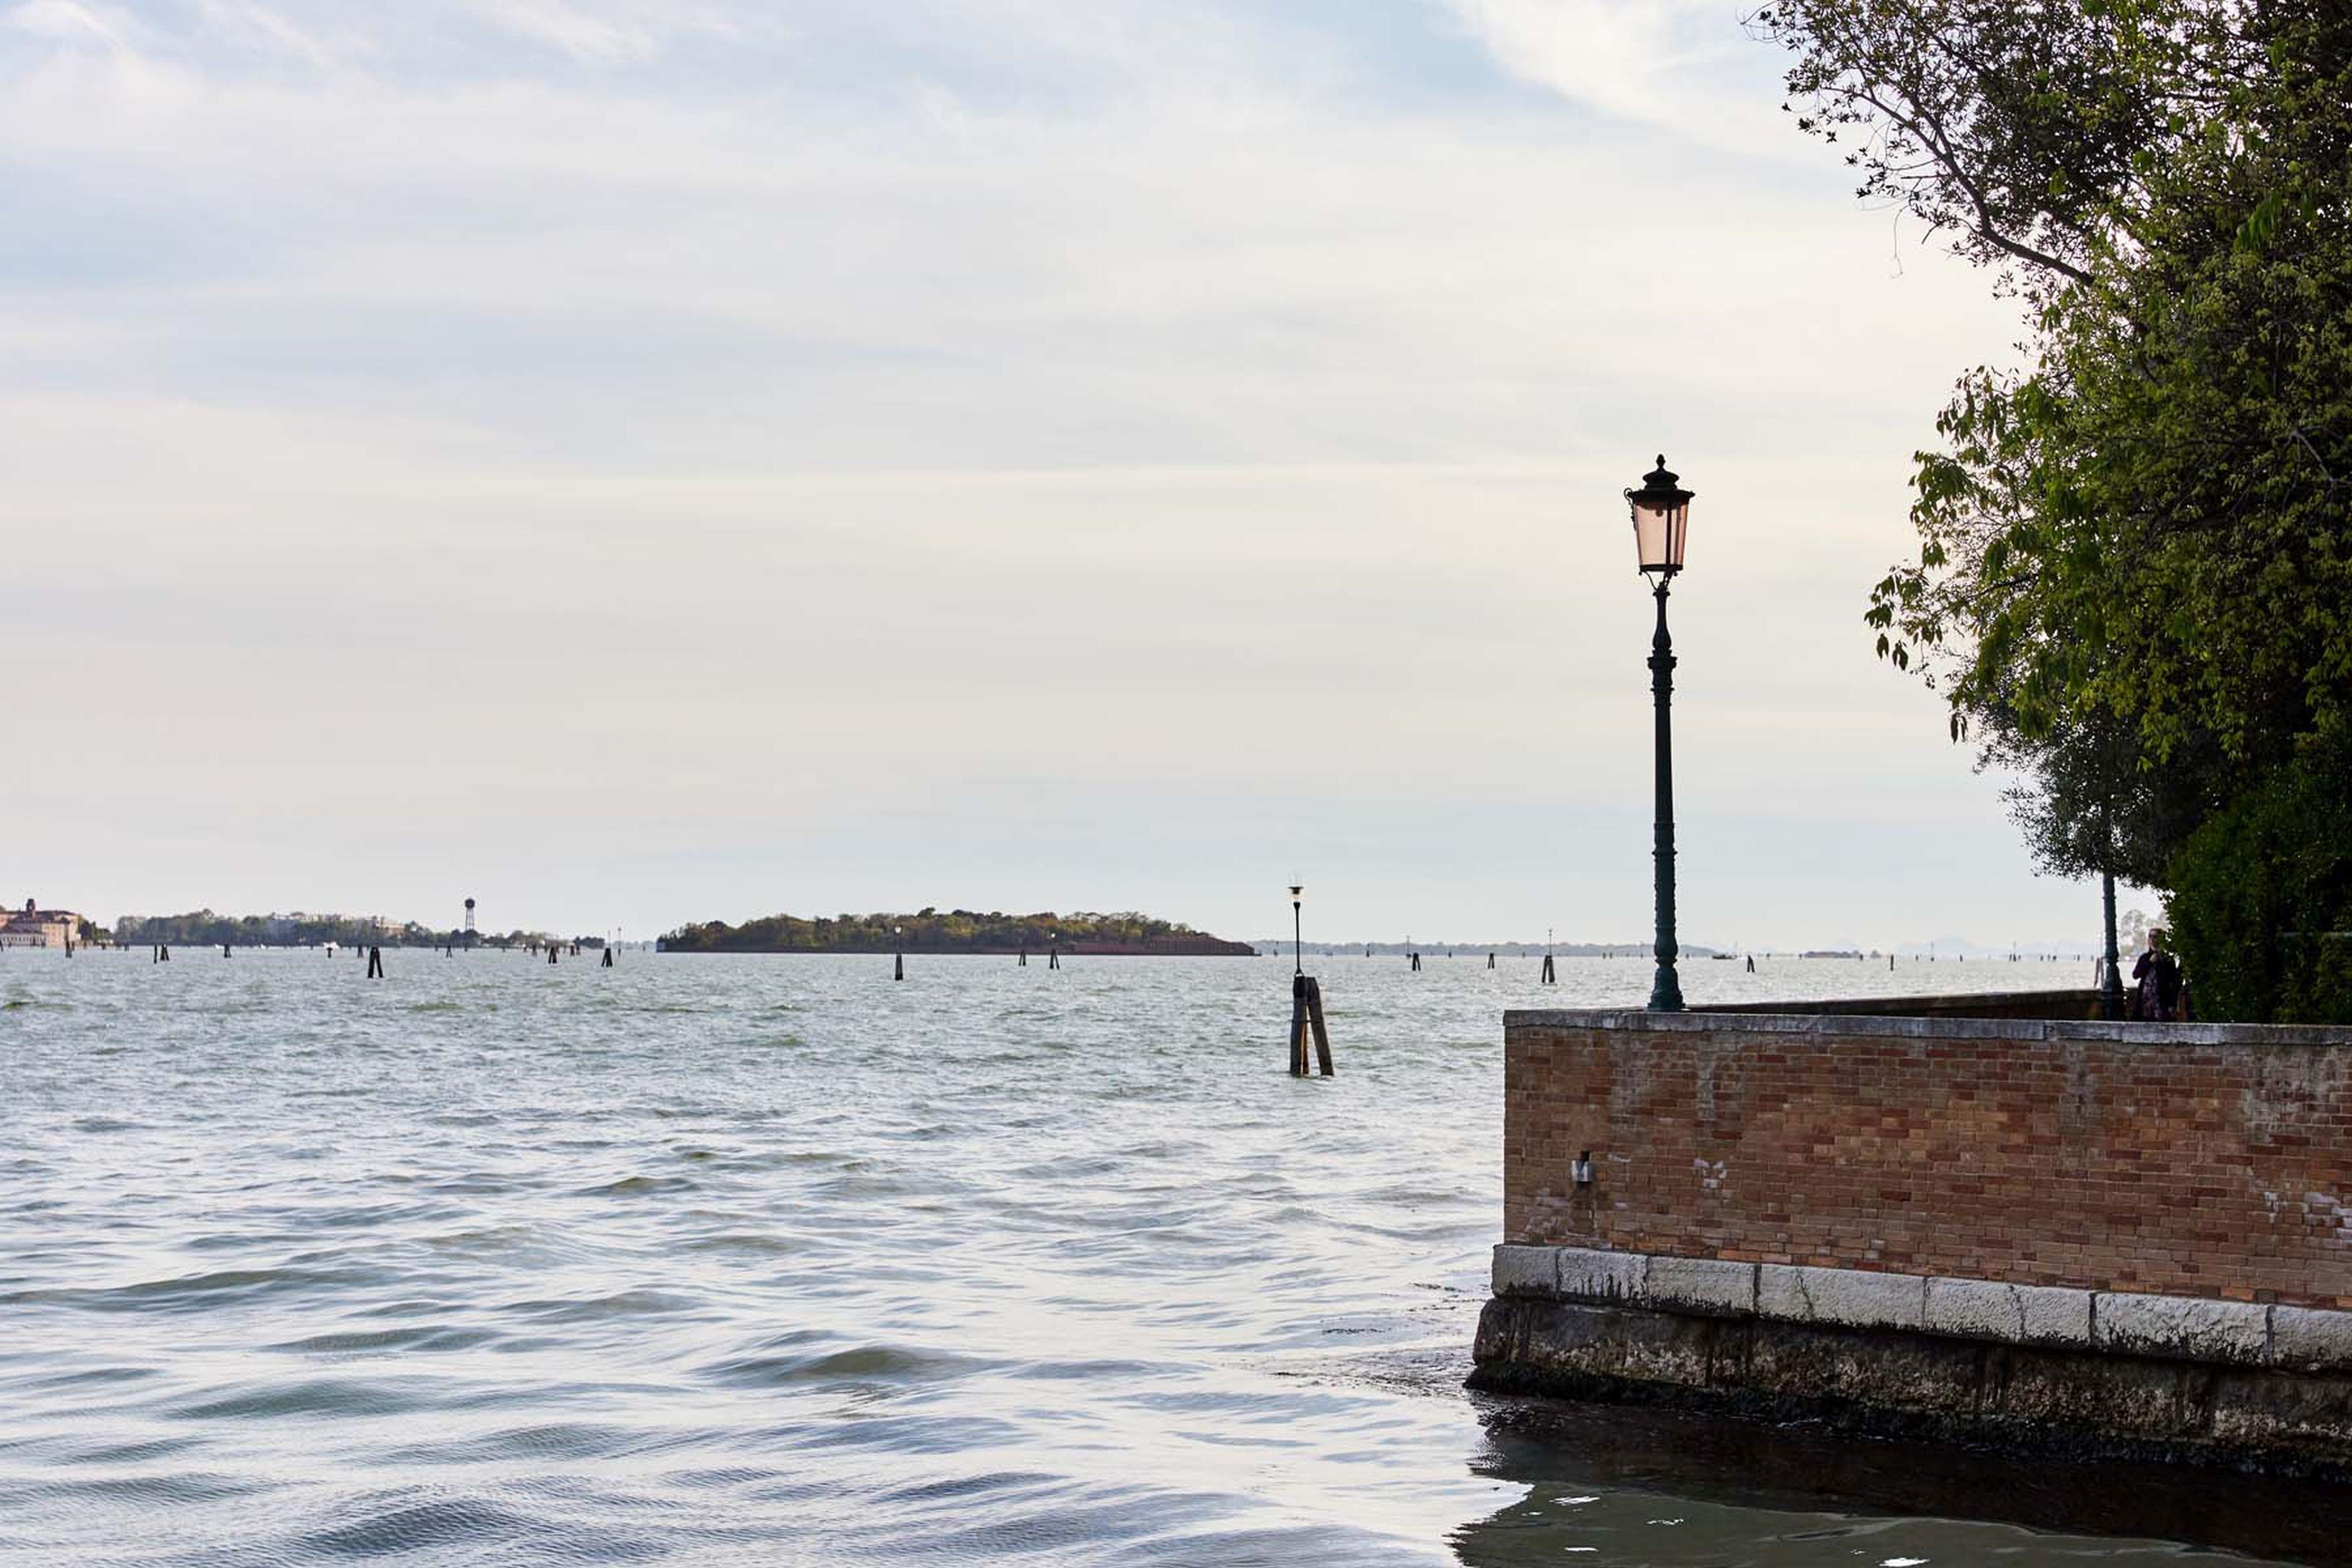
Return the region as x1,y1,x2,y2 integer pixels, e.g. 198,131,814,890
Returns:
0,950,2352,1568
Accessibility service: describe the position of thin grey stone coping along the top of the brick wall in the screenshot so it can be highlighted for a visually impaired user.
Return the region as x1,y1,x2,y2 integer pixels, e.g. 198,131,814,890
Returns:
1503,1001,2352,1046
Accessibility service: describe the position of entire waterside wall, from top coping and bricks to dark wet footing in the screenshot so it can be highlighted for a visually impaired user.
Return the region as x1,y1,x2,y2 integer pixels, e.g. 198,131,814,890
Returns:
1475,997,2352,1467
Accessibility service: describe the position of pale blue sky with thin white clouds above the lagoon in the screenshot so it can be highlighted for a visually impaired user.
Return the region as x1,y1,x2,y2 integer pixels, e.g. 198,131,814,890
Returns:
0,0,2154,947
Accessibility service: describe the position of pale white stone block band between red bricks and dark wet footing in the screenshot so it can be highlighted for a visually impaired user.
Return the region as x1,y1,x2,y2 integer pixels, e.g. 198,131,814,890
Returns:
1494,1251,2352,1373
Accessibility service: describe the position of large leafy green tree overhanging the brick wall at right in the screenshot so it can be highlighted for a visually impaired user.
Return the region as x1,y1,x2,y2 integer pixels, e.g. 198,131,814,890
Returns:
1750,0,2352,1022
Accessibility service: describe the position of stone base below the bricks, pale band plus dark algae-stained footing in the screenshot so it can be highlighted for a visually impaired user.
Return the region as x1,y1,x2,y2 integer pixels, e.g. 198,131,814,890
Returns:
1472,1246,2352,1476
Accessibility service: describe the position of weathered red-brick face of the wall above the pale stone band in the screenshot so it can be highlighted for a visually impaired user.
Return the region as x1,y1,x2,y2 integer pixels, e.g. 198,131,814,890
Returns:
1503,1013,2352,1307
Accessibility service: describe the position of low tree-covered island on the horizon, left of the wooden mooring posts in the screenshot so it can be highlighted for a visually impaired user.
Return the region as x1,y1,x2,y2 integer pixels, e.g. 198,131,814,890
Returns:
659,910,1256,959
